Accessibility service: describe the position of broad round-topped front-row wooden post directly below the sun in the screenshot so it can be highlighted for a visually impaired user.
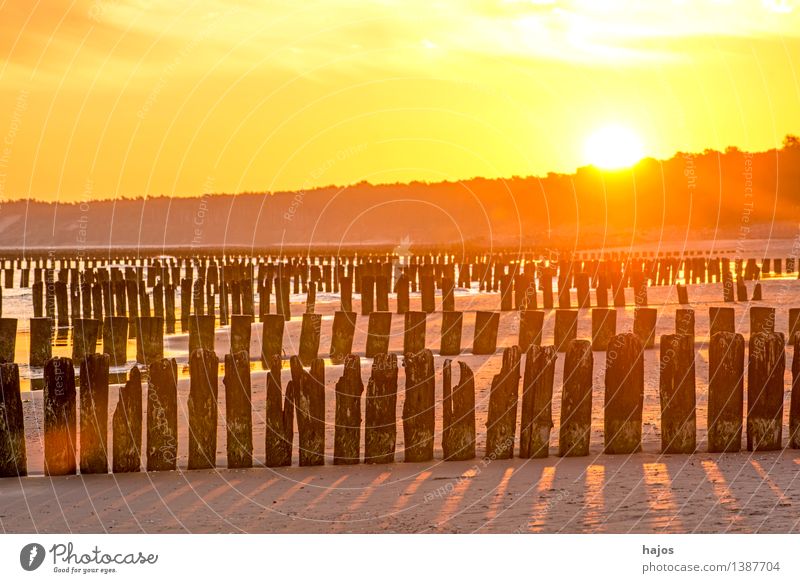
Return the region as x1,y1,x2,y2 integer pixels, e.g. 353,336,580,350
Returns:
604,334,644,454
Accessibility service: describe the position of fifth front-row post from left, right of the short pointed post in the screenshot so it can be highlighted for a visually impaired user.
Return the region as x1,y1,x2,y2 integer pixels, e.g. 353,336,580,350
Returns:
146,358,178,472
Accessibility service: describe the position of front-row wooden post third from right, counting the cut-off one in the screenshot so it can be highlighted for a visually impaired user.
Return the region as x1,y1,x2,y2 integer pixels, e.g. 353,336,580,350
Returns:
708,332,744,453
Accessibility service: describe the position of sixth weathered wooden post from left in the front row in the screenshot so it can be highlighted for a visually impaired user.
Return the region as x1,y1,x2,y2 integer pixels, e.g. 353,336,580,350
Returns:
187,348,219,470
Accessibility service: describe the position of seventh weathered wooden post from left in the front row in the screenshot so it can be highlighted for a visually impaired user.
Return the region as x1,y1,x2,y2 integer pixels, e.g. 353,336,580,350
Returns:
222,350,253,469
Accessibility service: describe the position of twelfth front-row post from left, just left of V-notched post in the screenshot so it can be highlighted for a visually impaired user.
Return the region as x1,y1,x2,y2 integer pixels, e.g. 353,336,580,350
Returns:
403,349,436,462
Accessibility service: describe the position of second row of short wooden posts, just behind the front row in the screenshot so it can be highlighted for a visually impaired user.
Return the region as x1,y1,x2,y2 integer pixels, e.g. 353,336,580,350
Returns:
9,306,800,368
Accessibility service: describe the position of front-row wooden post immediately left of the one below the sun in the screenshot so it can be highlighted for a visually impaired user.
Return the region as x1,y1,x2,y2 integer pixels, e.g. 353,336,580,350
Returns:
558,340,594,457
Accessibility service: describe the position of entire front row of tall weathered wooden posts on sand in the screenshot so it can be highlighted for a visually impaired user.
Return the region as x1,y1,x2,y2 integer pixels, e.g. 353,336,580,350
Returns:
0,332,800,477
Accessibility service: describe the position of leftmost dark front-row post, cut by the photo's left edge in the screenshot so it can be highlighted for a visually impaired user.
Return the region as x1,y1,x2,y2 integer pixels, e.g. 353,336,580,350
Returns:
0,362,28,478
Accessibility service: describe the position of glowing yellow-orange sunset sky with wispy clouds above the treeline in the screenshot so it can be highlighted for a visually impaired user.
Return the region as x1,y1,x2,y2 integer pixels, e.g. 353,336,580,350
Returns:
0,0,800,204
